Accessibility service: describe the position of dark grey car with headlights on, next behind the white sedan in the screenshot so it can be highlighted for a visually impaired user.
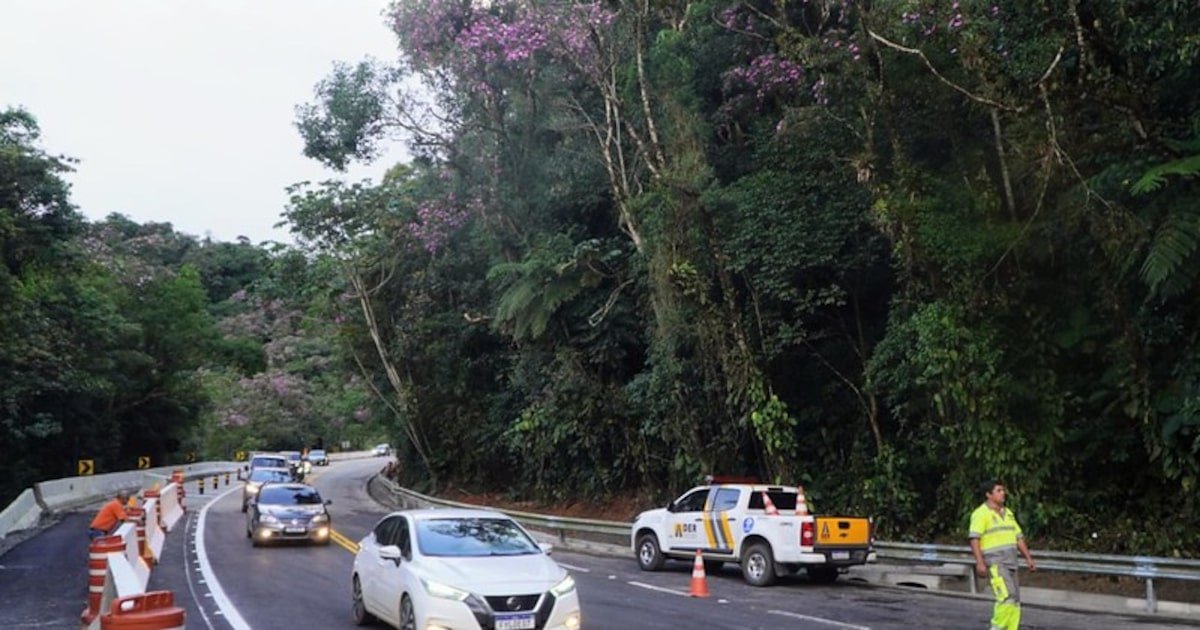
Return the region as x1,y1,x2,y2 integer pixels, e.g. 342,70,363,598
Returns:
246,484,332,547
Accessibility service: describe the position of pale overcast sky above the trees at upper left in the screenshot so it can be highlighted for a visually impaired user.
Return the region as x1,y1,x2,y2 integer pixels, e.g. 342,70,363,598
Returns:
0,0,406,242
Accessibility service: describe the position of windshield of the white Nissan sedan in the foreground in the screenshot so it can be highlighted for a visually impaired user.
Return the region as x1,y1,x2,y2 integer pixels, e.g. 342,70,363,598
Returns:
416,518,541,557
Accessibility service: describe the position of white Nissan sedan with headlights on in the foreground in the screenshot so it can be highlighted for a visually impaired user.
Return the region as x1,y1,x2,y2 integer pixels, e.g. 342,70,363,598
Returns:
350,509,581,630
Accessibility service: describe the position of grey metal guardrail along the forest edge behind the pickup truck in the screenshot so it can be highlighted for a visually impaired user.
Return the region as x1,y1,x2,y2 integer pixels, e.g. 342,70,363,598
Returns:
378,476,1200,612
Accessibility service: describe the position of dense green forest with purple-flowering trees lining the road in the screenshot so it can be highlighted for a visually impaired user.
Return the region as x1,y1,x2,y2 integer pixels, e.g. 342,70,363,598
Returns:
0,0,1200,556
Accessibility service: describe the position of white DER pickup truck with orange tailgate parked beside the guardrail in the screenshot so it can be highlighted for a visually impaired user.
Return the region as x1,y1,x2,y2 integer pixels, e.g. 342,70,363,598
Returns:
631,484,875,587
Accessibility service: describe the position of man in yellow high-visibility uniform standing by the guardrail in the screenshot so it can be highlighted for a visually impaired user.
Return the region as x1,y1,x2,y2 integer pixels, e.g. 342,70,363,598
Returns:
967,479,1038,630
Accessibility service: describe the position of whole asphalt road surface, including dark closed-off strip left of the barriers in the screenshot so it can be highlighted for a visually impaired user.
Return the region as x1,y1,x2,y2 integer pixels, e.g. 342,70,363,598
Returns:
0,460,1195,630
